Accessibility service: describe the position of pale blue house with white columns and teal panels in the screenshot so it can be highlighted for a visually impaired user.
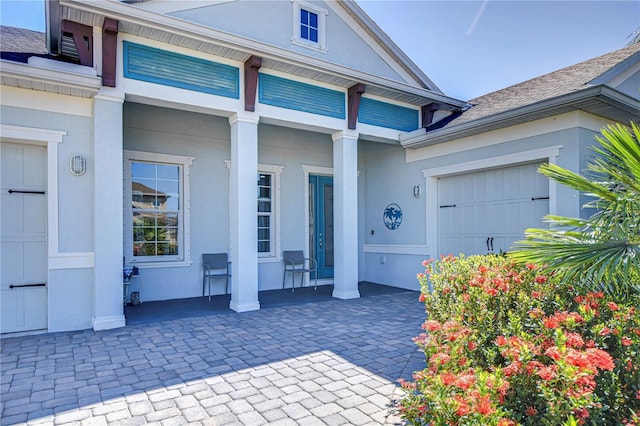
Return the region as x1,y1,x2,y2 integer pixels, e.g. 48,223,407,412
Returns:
0,0,640,334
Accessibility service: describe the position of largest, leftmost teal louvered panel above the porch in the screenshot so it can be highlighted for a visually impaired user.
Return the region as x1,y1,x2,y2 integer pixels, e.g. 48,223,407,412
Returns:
124,41,240,99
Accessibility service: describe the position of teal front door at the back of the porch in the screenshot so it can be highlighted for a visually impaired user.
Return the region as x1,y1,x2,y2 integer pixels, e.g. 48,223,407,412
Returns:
309,175,333,278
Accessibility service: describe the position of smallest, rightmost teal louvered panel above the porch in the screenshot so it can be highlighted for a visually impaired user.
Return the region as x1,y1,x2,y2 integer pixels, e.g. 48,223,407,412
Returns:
358,98,419,132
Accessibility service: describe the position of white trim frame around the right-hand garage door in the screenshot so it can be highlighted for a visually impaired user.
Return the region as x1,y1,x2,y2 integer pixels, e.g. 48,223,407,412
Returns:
422,145,562,256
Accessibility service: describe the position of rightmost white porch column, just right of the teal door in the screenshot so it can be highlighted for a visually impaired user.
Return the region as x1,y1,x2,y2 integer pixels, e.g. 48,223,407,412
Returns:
332,131,360,299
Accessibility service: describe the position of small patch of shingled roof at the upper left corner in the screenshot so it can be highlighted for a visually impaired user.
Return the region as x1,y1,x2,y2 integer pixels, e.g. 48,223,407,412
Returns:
0,25,47,63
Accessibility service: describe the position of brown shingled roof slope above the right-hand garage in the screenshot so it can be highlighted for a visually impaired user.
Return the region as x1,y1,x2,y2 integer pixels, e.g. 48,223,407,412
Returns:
427,43,640,131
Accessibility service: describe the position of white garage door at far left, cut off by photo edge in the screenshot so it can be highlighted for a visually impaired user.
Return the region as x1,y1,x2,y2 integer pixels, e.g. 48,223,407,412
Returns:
0,143,47,333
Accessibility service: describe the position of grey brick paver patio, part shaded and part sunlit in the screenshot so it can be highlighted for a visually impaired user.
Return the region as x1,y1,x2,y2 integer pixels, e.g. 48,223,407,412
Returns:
0,292,424,426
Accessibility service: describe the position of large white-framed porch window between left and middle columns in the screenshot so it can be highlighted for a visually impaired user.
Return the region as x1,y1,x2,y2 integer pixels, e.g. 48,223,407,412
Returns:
124,151,192,264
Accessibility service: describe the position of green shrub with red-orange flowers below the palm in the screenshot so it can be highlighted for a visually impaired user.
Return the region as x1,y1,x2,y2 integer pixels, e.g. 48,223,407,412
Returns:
398,256,640,425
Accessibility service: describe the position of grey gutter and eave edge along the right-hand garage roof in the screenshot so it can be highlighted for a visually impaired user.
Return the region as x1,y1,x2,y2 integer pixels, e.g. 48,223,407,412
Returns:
400,85,640,148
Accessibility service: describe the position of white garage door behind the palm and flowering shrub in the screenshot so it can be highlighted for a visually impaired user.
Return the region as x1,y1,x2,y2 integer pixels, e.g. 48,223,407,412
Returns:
438,163,549,255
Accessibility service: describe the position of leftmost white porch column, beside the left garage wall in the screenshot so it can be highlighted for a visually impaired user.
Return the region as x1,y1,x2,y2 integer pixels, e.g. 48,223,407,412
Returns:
92,95,125,331
